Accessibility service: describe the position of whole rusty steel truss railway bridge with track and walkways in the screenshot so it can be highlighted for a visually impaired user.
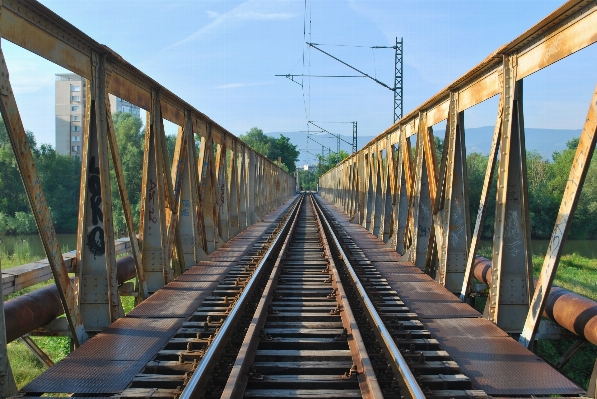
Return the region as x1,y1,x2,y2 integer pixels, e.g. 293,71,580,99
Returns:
0,0,597,399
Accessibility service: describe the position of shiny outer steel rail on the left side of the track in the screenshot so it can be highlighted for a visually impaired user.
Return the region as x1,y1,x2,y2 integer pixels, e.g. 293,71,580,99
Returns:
179,196,304,399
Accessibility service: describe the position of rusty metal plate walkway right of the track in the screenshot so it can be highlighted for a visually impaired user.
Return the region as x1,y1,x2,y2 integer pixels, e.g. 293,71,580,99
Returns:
320,197,584,397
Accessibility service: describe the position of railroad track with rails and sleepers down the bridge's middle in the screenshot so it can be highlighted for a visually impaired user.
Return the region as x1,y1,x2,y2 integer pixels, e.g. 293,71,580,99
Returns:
120,195,486,399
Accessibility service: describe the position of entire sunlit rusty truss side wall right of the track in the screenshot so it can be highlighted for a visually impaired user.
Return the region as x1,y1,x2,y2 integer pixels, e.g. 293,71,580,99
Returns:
319,0,597,347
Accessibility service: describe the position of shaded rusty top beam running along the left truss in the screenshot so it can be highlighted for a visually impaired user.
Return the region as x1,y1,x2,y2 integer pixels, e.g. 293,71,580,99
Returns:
0,0,292,177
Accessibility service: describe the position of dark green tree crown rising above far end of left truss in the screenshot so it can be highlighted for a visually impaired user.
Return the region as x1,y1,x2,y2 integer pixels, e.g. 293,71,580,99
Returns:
240,127,300,173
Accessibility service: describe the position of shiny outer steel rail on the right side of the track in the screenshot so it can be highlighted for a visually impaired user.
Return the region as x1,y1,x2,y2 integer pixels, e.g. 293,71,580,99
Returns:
315,196,425,399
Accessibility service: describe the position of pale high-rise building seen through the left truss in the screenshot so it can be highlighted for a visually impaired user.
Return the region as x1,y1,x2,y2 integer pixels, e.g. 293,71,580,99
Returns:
56,73,141,156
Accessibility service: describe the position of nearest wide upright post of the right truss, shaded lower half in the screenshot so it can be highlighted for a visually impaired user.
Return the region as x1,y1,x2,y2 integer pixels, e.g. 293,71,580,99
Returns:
485,56,533,334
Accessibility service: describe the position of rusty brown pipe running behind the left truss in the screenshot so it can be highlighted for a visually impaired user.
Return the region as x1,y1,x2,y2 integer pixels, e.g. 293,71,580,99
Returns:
4,256,136,342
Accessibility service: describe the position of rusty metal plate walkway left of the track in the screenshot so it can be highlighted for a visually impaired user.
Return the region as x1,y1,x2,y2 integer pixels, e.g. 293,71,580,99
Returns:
20,201,292,396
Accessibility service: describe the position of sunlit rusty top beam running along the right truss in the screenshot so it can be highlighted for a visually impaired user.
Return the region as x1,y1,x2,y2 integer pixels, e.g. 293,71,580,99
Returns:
322,0,597,162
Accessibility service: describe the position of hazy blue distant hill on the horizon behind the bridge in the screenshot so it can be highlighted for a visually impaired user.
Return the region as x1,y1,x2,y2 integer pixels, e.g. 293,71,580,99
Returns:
267,126,581,164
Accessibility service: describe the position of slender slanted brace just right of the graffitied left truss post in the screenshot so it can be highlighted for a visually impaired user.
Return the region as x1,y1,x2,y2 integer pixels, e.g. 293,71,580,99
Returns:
105,71,148,302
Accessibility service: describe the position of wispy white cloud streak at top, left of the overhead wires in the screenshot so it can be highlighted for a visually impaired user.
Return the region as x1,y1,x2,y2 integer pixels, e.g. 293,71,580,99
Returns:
166,0,301,49
